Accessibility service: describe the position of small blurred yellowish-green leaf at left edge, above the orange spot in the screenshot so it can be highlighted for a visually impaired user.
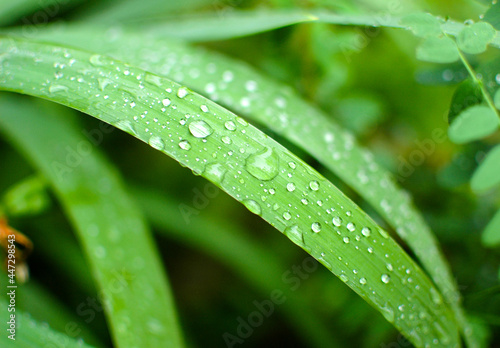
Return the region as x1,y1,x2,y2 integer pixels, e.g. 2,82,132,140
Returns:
2,177,50,216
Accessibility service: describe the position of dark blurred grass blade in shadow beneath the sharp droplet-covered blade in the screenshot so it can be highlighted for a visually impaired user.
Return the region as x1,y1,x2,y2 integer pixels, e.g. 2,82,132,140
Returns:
130,186,341,348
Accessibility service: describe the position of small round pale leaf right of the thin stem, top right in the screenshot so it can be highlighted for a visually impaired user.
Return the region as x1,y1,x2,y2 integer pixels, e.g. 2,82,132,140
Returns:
457,22,496,54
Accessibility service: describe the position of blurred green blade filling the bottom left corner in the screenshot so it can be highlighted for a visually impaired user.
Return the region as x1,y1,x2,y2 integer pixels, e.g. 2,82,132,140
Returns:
0,297,95,348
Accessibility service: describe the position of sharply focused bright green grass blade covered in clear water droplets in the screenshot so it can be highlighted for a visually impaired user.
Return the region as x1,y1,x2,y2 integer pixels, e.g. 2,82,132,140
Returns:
0,38,458,346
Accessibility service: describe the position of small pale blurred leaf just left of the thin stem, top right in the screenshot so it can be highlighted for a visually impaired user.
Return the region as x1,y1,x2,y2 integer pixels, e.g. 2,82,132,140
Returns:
417,36,460,63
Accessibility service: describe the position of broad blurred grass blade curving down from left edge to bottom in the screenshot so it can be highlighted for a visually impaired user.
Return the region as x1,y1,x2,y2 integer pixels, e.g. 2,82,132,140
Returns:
0,96,186,347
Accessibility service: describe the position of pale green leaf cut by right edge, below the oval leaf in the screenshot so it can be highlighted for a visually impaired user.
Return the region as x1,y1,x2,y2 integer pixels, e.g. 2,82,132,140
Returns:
471,145,500,192
